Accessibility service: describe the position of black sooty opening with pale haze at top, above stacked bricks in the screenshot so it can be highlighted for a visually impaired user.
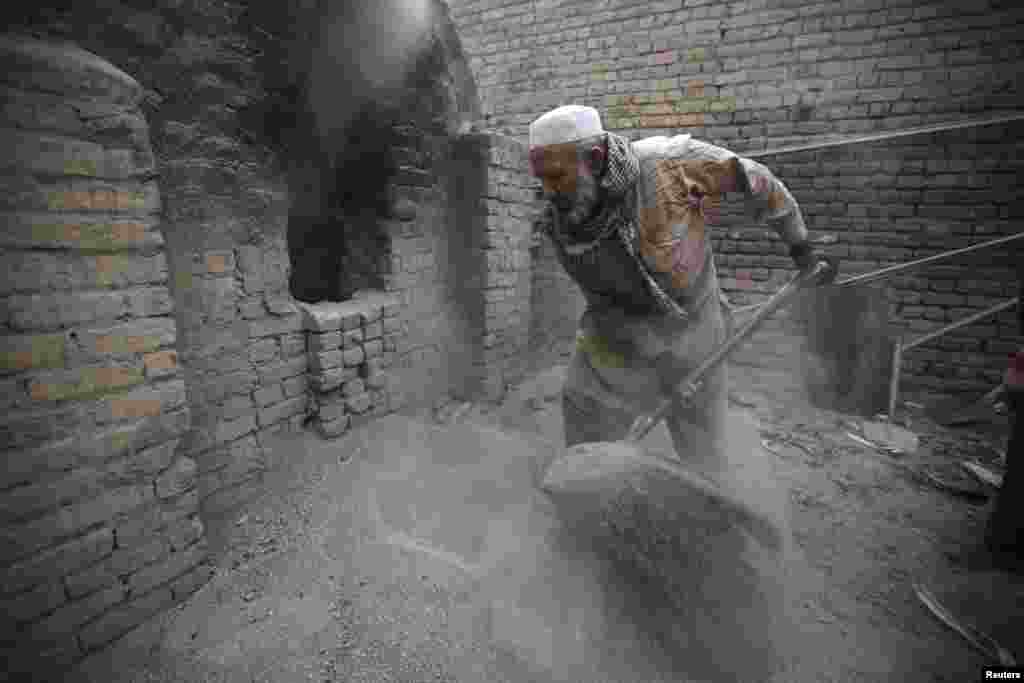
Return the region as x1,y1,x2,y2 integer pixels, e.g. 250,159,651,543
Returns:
238,0,475,302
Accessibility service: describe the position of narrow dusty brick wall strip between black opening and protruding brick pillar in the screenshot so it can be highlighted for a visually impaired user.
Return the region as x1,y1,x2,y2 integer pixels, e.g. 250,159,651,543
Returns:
383,130,482,410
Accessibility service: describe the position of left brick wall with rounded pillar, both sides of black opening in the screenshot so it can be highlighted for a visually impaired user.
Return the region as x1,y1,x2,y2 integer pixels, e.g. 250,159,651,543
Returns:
0,0,483,667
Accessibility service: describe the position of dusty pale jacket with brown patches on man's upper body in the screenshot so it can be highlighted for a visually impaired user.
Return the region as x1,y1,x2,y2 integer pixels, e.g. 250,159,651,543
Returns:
540,133,807,319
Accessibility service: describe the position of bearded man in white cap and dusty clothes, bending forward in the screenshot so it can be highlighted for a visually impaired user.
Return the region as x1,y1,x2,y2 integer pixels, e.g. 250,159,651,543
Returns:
529,105,823,460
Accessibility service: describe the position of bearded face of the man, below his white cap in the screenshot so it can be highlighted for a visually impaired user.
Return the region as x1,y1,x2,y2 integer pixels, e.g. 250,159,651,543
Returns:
530,142,598,225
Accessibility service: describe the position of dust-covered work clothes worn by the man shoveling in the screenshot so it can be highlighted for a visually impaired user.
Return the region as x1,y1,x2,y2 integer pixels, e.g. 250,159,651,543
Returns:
541,134,807,456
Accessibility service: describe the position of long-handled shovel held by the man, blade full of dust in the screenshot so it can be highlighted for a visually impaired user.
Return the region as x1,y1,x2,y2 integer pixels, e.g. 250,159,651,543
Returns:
540,259,837,548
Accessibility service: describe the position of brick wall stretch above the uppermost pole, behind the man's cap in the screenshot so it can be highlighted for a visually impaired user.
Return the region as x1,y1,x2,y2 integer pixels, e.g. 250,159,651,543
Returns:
449,0,1024,147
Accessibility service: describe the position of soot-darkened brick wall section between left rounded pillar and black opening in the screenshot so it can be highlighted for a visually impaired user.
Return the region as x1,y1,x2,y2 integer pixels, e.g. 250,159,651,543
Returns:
52,3,306,519
